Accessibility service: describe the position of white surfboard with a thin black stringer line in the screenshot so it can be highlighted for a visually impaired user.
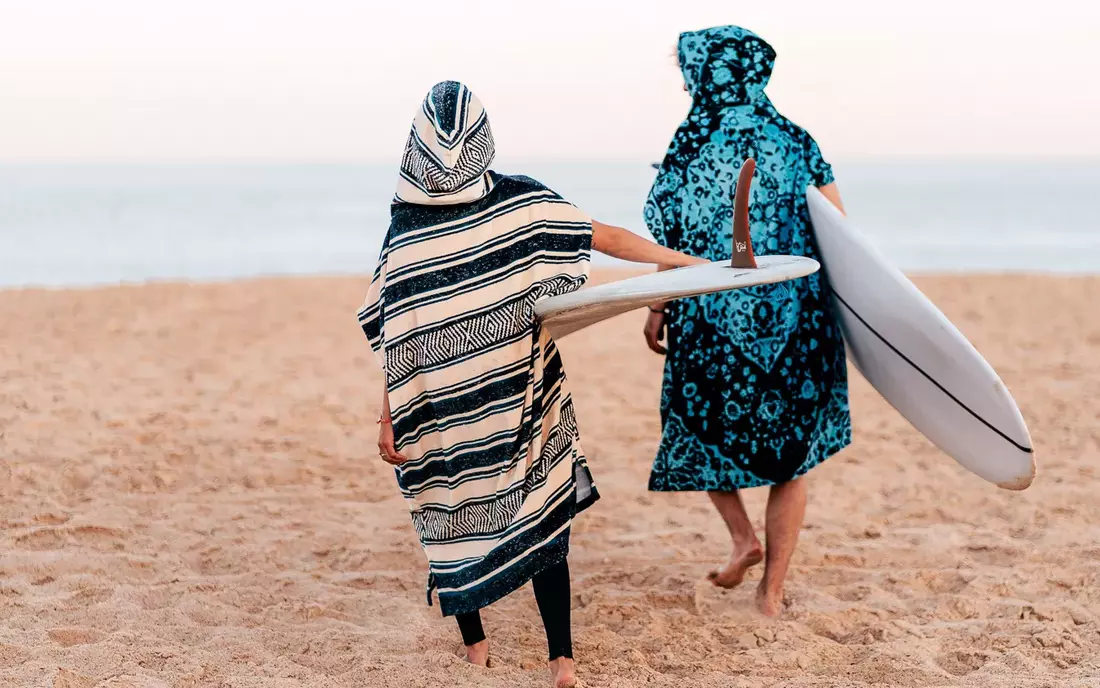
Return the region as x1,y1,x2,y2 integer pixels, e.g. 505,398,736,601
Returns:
806,187,1035,490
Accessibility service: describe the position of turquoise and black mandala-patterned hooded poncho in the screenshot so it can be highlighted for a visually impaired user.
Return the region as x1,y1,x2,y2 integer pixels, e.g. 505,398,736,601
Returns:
646,26,851,491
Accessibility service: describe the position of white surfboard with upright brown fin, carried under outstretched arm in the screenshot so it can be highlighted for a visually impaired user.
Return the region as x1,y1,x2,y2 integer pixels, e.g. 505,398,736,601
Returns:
535,255,821,339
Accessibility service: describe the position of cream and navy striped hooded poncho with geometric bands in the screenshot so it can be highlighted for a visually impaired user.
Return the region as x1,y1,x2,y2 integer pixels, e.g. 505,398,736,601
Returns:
359,81,598,615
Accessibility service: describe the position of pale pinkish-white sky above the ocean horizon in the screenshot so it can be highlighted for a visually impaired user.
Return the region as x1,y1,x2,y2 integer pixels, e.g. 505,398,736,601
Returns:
0,0,1100,163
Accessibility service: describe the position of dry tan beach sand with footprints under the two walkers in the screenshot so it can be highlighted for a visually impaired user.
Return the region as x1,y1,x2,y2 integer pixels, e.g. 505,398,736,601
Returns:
0,275,1100,688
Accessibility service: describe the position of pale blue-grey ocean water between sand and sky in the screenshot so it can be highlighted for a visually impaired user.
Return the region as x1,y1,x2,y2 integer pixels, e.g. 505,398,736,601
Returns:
0,161,1100,287
